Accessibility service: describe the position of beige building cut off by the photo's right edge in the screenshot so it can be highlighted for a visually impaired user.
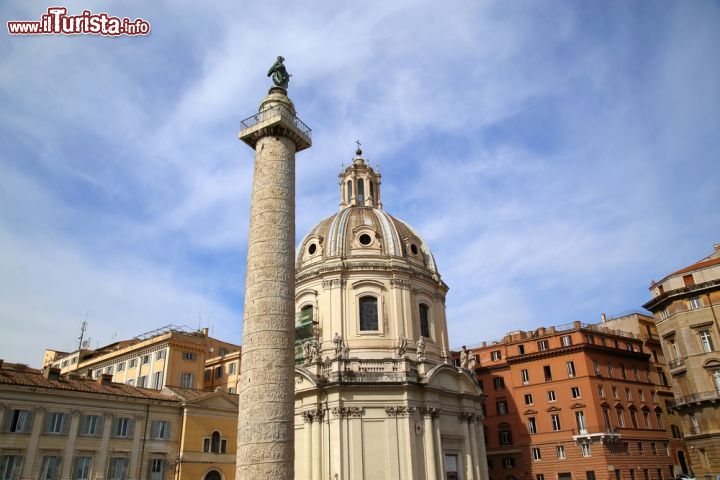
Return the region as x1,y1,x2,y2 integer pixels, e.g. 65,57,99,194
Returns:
644,244,720,479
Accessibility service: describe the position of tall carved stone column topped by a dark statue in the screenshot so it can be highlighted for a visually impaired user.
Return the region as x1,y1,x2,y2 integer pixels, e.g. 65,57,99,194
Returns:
236,57,311,480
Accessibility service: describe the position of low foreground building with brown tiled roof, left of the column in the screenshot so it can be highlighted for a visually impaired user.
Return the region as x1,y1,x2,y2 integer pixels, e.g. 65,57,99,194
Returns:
0,360,237,480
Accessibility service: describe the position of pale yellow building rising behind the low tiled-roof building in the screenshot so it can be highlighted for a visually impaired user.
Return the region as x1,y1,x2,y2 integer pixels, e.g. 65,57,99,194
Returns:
43,325,240,390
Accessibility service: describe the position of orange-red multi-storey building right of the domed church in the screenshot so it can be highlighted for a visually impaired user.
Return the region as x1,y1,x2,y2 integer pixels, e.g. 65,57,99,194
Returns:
469,322,679,480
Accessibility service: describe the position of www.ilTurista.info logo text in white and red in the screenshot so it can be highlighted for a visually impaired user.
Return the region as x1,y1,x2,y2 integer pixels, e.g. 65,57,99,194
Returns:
7,7,150,37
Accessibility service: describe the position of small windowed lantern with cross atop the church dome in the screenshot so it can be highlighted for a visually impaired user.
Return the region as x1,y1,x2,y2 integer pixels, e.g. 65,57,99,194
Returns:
338,140,382,210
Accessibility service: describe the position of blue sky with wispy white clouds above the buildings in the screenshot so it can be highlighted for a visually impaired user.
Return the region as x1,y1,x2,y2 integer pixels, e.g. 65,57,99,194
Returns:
0,0,720,365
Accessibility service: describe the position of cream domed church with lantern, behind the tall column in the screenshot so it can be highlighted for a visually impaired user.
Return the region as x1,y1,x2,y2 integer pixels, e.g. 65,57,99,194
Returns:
295,149,487,480
